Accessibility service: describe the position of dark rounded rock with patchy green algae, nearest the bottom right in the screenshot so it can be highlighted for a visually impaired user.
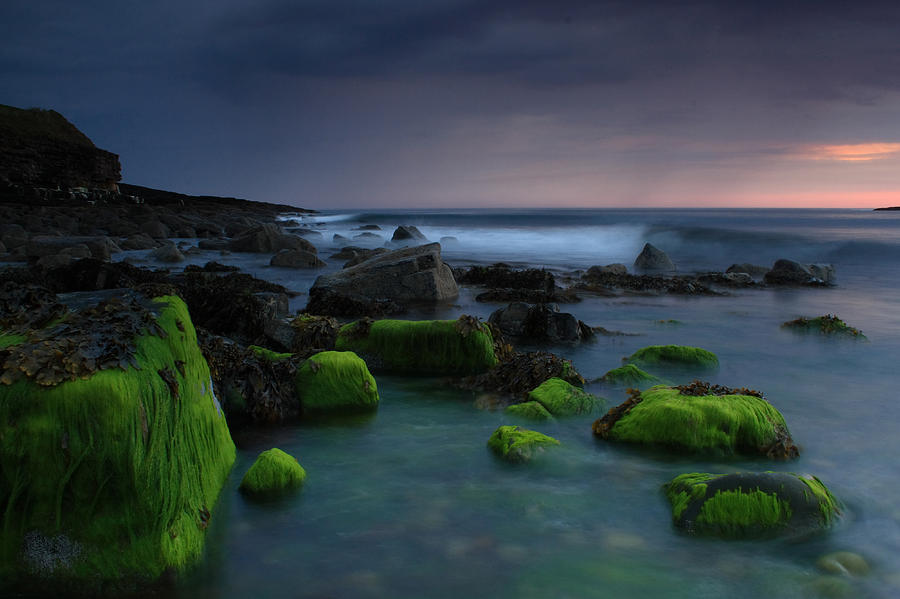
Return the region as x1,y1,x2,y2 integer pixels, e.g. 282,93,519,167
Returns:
664,472,841,538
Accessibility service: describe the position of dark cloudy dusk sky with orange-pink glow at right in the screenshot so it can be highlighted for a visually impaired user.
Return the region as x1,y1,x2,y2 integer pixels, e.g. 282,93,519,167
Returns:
0,0,900,209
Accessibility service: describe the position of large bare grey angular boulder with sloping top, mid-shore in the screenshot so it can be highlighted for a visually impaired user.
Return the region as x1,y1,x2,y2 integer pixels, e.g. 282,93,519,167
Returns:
307,243,459,316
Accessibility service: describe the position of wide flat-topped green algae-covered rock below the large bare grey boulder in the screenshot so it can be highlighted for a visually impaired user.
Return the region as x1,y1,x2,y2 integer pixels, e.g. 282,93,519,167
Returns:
335,316,497,374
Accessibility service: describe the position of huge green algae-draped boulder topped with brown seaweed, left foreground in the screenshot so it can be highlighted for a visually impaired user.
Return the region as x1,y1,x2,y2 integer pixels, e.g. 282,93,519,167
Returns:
0,296,235,591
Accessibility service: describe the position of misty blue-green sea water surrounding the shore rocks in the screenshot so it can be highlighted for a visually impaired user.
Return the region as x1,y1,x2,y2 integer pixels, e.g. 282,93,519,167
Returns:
122,210,900,599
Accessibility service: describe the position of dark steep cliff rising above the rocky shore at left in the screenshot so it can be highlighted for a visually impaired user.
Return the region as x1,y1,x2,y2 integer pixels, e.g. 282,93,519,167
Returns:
0,104,122,189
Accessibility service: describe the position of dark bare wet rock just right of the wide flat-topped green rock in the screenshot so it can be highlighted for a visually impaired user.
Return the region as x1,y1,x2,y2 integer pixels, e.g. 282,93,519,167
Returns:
488,302,593,343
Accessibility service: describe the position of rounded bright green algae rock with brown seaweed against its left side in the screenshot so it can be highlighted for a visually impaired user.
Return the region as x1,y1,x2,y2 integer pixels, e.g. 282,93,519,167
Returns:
296,351,378,413
